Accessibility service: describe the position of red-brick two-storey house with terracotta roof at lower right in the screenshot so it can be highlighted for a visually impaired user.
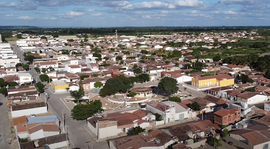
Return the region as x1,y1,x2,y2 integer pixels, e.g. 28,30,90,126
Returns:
214,109,241,126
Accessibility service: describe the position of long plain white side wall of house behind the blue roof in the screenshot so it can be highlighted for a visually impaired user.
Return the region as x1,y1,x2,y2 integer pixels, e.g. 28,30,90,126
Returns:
11,106,47,118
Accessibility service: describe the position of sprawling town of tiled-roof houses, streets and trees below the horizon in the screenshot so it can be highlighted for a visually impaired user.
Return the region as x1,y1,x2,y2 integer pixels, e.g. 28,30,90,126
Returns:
0,29,270,149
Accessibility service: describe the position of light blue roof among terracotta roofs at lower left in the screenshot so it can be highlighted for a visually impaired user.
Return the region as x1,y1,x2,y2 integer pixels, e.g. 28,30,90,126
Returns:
27,115,59,124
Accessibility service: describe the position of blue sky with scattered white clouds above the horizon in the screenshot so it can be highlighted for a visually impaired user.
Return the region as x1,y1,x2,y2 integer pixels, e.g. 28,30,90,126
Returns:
0,0,270,27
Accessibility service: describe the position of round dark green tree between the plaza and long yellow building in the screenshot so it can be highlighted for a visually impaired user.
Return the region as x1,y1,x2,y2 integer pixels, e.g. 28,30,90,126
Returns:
158,77,178,97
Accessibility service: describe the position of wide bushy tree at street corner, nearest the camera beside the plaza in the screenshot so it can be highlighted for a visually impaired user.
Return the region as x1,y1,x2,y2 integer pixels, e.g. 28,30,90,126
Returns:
71,100,103,120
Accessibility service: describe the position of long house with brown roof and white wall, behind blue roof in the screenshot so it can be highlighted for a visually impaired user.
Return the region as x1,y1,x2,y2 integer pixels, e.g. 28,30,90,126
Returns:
10,102,47,118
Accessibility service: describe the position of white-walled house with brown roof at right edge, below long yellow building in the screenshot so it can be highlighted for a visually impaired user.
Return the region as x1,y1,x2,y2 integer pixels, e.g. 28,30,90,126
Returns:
237,91,268,107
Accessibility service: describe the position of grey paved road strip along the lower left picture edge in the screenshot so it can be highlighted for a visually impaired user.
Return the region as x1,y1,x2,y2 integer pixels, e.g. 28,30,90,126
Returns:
0,94,10,149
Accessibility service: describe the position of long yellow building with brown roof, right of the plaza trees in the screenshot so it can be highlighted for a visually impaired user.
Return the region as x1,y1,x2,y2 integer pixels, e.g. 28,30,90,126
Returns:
192,74,234,88
